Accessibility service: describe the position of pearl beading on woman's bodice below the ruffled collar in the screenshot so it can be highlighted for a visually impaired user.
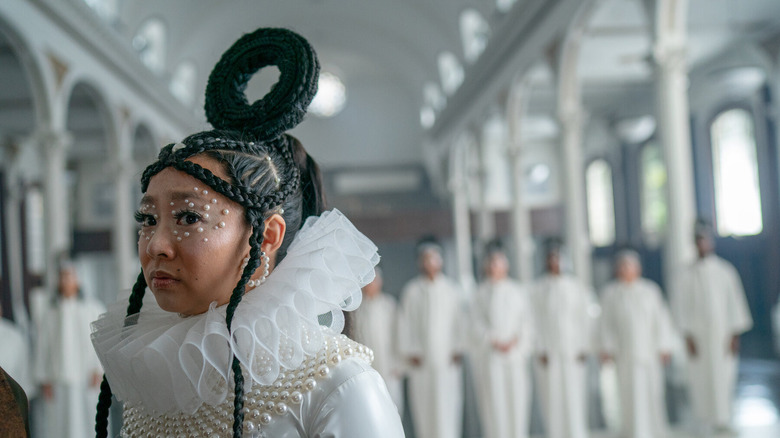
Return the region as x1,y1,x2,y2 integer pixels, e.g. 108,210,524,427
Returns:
121,335,374,438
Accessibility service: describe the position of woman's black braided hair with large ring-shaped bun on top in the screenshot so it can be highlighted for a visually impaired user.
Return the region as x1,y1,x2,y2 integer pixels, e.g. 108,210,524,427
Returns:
95,28,325,438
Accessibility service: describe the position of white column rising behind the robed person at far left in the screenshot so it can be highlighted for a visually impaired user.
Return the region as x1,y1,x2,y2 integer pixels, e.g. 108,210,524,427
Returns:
36,129,72,296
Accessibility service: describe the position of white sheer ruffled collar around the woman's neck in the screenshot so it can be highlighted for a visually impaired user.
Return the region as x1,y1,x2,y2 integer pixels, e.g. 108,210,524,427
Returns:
92,210,379,413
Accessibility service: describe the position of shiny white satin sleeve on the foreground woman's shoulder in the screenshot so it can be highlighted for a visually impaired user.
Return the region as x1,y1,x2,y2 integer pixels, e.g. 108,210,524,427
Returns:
306,361,404,438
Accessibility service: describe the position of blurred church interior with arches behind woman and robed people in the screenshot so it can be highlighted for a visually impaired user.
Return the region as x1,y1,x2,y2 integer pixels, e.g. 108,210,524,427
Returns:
0,0,780,436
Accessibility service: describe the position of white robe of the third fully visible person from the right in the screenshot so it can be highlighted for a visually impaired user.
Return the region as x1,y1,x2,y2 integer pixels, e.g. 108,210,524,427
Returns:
532,275,595,438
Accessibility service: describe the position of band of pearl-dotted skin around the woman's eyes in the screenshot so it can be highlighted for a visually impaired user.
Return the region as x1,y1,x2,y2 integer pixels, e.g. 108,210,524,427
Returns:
136,187,230,243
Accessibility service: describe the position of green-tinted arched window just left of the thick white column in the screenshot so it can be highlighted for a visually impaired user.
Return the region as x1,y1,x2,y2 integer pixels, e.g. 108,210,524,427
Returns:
639,141,668,242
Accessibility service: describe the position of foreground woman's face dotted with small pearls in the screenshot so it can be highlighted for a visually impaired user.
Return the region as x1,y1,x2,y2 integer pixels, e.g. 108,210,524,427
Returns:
138,156,251,315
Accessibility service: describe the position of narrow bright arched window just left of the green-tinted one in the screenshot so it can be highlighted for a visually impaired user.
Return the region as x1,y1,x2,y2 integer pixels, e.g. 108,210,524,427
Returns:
585,159,615,246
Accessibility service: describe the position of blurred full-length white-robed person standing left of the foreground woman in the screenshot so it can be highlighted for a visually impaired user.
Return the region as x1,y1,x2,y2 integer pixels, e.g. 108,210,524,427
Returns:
35,266,105,438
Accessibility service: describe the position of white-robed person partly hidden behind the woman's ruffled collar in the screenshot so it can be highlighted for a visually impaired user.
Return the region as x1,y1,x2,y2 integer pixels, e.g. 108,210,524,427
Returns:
352,268,404,413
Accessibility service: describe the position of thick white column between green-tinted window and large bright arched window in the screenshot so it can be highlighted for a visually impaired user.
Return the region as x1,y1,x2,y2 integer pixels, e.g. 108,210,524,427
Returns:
654,42,696,293
